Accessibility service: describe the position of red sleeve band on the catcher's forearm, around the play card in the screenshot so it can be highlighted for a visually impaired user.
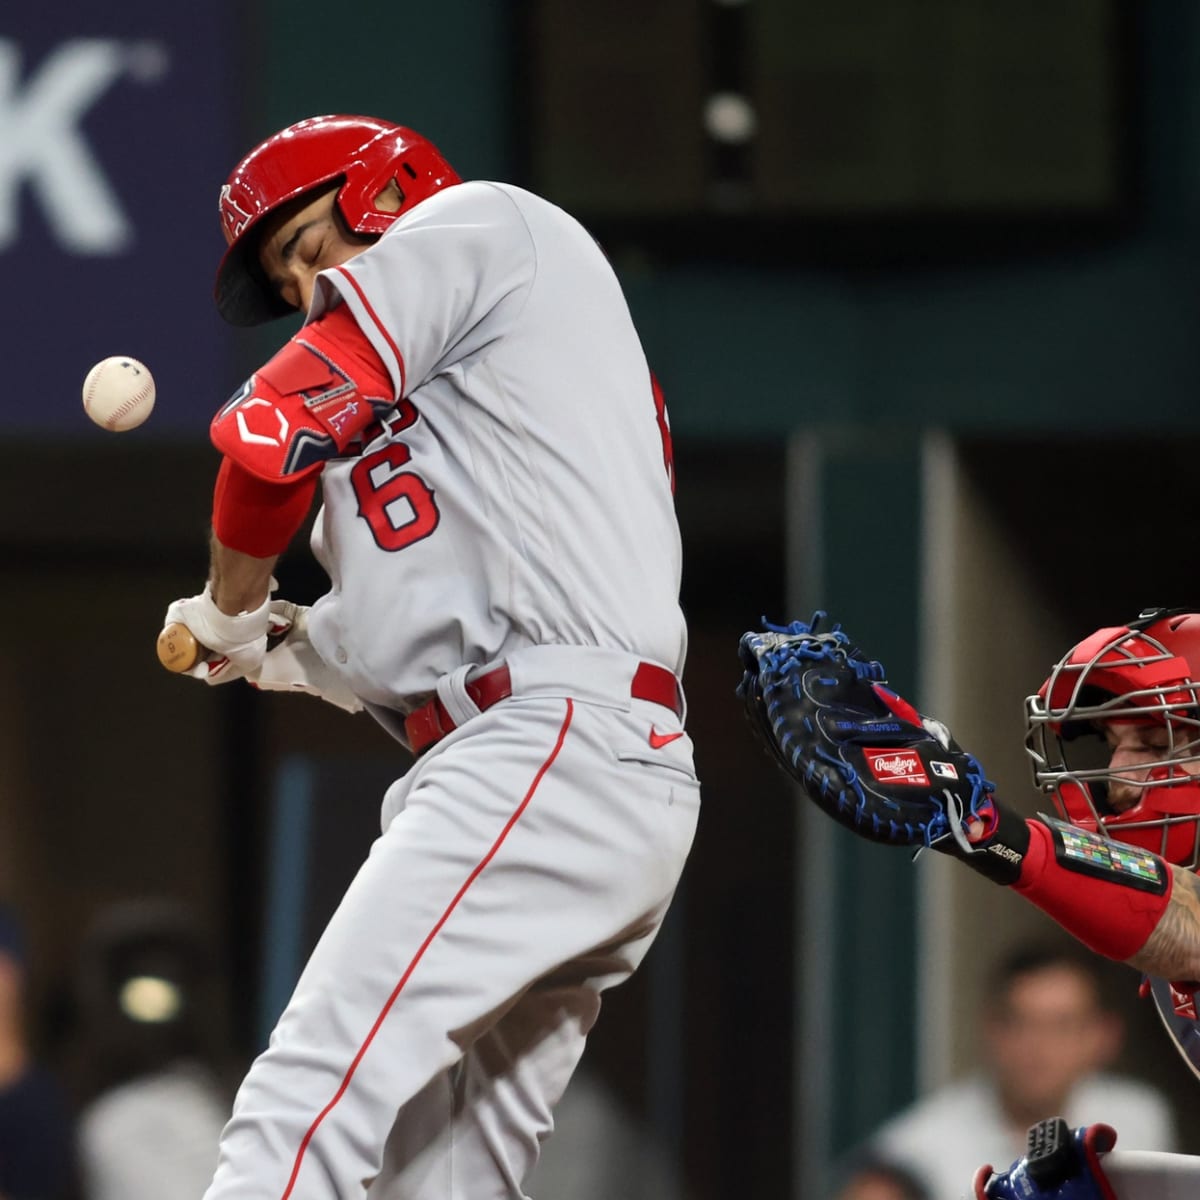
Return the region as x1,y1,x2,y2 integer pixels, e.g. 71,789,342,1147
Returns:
1014,817,1174,961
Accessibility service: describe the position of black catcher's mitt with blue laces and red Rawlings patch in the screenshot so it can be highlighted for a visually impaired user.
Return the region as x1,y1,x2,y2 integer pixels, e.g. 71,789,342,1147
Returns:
737,612,995,856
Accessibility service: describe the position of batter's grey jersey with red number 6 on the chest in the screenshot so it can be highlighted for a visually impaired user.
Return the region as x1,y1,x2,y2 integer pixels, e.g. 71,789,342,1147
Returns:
310,182,686,707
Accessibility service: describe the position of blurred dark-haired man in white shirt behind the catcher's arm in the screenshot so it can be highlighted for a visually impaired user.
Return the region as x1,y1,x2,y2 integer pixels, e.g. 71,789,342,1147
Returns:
869,946,1176,1200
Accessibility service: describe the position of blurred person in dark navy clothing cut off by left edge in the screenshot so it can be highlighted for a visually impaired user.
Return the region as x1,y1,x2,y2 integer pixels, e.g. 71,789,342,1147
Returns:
0,904,74,1200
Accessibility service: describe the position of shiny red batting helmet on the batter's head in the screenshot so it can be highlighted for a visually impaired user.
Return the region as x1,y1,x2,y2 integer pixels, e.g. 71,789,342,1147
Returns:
216,115,461,325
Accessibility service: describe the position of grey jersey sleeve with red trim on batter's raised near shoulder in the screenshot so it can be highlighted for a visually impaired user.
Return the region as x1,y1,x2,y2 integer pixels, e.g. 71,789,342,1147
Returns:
313,182,536,396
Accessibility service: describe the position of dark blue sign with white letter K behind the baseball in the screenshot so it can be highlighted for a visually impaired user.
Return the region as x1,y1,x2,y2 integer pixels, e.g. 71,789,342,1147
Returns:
0,0,247,438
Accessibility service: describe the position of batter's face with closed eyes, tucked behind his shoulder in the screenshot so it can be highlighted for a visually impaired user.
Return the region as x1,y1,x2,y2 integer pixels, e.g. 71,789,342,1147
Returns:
258,184,372,312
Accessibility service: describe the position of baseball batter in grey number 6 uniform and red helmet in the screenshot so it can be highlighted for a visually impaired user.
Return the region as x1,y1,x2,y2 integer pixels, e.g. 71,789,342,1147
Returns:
167,116,700,1200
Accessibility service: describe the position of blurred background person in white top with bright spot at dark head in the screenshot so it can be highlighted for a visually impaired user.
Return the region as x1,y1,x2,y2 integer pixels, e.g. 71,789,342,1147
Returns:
71,901,232,1200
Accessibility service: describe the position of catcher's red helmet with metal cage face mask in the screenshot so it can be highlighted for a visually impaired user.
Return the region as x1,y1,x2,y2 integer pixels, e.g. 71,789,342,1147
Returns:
1025,608,1200,870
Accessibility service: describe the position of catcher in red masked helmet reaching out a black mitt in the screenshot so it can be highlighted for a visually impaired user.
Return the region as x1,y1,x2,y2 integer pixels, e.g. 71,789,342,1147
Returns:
738,608,1200,1200
